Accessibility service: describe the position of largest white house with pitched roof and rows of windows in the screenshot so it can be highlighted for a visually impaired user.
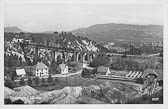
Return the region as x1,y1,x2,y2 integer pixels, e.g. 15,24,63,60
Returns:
32,62,49,77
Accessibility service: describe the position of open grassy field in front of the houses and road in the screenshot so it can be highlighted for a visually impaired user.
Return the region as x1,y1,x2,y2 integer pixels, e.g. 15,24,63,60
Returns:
35,75,141,92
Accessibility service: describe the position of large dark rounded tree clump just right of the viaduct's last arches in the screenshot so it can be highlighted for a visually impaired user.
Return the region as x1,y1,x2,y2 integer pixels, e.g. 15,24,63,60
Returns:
90,53,110,67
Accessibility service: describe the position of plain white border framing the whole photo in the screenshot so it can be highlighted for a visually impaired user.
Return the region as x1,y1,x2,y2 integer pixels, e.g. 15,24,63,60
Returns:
0,0,168,109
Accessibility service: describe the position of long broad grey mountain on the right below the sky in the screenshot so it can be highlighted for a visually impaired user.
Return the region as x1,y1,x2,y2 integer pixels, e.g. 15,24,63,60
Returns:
72,23,163,42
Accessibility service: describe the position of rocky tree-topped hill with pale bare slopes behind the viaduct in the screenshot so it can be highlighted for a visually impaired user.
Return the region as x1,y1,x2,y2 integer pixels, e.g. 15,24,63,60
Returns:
4,32,107,52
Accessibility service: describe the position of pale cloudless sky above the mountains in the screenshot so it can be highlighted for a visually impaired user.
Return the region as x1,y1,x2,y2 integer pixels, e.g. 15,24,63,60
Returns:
4,0,163,32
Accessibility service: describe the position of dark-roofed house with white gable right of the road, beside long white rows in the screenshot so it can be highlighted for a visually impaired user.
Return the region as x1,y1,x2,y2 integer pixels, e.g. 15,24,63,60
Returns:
97,66,111,76
